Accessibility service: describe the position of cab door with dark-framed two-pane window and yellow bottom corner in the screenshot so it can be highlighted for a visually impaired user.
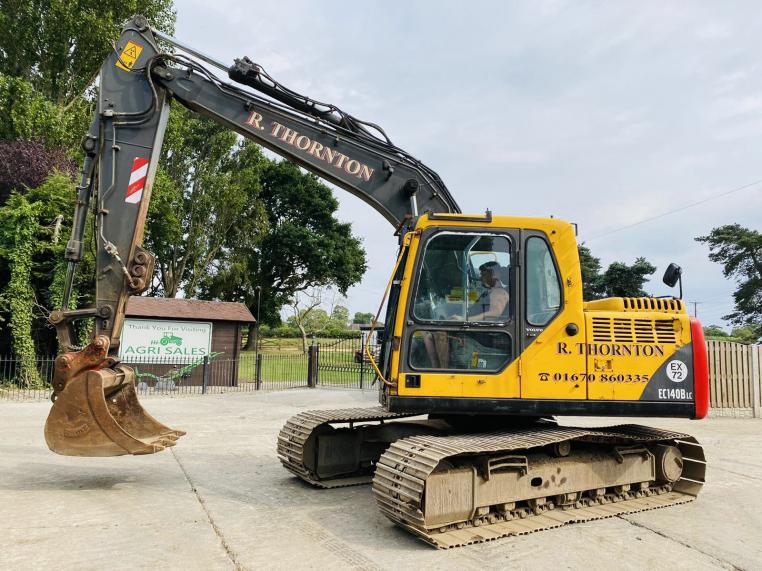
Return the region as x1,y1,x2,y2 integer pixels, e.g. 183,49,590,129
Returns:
398,226,519,398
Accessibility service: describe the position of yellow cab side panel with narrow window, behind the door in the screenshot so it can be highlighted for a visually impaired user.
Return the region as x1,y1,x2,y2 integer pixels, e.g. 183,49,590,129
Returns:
519,231,587,400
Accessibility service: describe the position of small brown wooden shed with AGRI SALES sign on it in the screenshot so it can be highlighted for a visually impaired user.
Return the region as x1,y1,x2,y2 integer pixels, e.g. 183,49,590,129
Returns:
119,297,255,386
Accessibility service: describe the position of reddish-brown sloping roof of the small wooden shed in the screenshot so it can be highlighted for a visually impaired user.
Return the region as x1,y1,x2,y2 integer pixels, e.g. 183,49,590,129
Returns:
125,296,256,323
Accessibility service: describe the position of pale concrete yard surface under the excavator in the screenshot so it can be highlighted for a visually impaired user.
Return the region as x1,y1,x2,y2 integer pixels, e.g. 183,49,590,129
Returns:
0,389,762,571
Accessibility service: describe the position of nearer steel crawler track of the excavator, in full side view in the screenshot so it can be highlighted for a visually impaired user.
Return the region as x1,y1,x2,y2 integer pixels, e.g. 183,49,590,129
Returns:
373,424,706,549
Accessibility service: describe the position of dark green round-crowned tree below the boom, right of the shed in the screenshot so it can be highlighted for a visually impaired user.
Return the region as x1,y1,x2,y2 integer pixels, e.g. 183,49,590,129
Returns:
203,161,366,349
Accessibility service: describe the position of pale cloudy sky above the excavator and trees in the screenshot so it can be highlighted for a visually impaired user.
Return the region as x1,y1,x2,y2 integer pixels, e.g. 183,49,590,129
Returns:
175,0,762,325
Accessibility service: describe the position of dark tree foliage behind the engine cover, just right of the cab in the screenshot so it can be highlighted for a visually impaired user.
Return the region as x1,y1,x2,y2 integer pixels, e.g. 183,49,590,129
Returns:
579,245,656,301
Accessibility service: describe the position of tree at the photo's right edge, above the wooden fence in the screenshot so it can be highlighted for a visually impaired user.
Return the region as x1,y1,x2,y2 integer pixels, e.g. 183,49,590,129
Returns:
696,224,762,330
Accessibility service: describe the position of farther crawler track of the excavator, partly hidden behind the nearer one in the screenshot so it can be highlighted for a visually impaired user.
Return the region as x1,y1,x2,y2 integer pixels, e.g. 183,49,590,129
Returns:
278,407,414,488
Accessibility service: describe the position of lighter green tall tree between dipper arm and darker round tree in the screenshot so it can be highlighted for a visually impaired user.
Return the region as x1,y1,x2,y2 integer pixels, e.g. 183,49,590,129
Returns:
145,106,267,297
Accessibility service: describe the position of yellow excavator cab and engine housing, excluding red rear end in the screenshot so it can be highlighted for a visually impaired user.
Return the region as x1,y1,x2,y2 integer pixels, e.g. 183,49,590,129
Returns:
380,215,696,417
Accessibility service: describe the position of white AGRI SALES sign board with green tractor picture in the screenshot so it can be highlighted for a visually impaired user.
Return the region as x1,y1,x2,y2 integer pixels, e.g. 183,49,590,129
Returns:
119,319,212,363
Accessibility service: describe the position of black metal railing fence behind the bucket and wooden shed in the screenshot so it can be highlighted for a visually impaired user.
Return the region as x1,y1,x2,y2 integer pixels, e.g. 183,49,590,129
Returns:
0,337,378,400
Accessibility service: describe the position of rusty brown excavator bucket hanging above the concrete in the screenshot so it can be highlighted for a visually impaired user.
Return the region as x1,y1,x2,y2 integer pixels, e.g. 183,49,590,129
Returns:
45,336,185,456
